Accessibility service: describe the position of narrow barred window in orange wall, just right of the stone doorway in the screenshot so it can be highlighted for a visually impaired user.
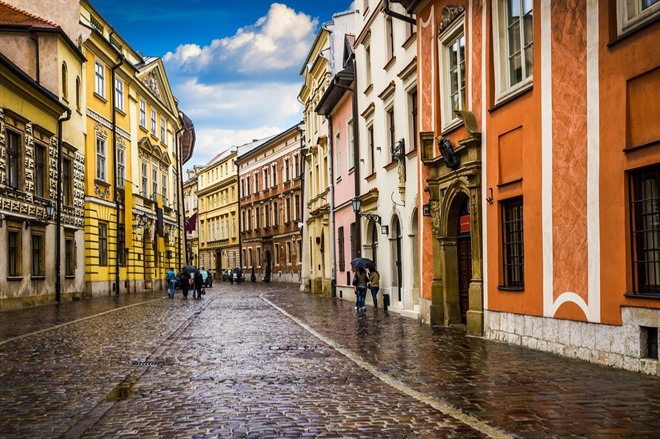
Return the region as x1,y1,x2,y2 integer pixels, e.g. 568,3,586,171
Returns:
502,197,525,290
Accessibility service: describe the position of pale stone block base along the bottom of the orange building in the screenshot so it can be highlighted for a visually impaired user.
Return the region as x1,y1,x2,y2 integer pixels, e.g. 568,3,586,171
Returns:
484,307,660,376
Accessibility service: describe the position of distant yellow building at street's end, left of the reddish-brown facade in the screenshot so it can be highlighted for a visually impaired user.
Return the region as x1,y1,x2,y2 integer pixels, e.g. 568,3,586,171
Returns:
197,148,240,277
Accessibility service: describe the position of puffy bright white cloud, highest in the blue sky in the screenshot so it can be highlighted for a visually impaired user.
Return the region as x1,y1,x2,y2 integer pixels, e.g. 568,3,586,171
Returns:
164,3,318,73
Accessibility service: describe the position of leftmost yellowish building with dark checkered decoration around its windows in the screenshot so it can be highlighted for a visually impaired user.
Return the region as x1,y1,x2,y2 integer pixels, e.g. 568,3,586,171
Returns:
0,3,85,310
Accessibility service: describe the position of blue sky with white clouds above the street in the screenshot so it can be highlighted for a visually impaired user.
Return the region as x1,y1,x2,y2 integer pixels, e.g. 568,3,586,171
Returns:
92,0,352,169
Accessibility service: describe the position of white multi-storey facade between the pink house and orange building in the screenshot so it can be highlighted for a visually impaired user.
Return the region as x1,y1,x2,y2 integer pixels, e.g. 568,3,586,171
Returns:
355,0,422,318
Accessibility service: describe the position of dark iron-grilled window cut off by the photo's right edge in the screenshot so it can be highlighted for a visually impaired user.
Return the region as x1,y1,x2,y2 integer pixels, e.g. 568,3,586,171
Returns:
628,165,660,295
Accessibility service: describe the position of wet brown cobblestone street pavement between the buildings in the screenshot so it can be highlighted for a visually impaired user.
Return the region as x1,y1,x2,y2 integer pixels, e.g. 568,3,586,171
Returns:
0,282,660,438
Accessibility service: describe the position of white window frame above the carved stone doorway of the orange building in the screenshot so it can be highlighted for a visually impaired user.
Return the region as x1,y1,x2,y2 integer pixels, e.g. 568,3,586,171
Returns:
438,18,469,132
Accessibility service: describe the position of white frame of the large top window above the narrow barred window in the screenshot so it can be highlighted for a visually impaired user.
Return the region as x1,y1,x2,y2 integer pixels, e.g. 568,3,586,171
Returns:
493,0,534,104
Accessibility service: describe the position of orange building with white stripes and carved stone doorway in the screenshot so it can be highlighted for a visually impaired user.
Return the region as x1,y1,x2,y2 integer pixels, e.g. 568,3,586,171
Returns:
402,0,660,374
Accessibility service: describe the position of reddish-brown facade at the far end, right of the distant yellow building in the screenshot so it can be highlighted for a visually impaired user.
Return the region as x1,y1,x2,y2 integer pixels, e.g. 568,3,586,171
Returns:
236,124,303,282
